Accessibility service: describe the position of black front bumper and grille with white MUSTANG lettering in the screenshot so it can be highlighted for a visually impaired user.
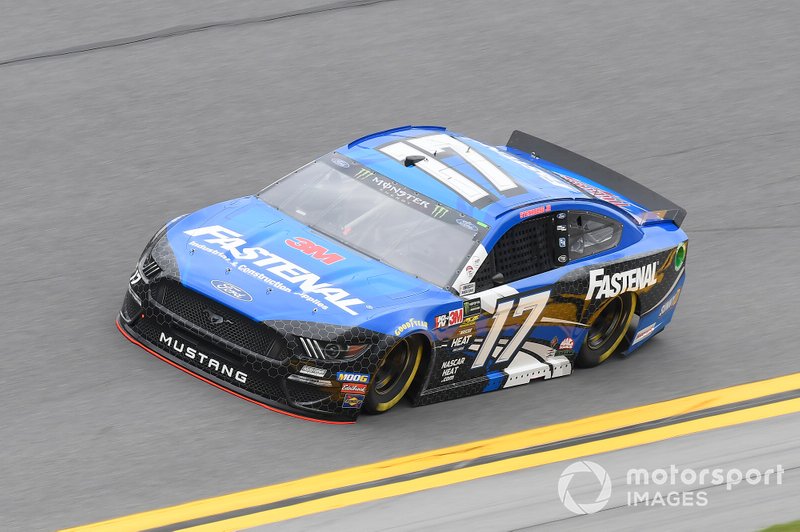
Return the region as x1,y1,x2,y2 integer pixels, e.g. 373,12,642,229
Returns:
117,278,391,423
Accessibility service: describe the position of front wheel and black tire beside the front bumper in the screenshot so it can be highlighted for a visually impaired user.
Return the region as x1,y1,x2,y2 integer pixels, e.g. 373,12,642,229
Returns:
364,336,423,414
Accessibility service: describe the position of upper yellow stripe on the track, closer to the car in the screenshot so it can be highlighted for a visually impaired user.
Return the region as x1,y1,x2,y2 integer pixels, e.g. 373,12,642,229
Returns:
64,373,800,531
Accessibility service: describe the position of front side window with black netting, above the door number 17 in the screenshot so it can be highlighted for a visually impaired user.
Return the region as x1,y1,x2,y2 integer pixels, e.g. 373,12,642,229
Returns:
472,215,556,291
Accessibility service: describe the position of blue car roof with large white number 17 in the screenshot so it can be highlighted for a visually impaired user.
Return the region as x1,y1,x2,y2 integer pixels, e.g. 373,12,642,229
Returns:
336,126,591,223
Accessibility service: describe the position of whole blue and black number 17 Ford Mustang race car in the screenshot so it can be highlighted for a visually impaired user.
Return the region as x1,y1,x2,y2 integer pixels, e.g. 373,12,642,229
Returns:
117,126,687,423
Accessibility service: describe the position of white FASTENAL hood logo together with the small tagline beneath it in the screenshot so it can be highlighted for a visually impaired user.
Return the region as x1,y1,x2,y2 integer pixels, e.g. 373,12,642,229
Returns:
184,225,365,316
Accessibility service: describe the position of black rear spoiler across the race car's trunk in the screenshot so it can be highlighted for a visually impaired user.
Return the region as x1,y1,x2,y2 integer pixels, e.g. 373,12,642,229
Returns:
506,131,686,227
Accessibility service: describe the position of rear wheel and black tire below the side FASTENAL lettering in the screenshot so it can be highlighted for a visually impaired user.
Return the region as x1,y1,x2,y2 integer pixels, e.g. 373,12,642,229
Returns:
575,294,636,368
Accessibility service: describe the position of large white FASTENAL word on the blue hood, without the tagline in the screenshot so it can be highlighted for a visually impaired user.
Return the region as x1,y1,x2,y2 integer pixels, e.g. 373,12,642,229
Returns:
184,225,364,316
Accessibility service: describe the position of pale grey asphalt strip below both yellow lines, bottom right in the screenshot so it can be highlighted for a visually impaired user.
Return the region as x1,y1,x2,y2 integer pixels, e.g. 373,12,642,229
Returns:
268,414,800,532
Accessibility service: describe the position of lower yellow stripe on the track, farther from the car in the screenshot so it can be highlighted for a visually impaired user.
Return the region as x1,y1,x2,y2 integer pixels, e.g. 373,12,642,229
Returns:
180,399,800,532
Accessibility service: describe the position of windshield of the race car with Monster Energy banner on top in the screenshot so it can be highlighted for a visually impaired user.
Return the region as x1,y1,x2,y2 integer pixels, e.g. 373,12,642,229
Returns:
259,153,488,287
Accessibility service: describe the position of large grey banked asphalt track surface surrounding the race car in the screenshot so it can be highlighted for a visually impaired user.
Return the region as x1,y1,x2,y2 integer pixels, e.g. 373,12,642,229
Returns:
0,0,800,529
